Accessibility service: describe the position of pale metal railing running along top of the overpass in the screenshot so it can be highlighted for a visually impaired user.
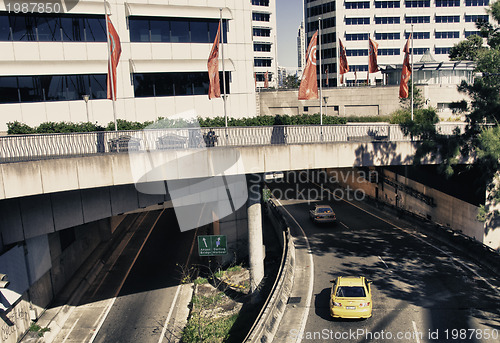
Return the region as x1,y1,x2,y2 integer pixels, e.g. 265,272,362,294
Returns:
0,123,466,163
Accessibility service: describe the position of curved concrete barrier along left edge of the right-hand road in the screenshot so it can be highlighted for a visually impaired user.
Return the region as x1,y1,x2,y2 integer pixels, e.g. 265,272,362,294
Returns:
243,200,295,343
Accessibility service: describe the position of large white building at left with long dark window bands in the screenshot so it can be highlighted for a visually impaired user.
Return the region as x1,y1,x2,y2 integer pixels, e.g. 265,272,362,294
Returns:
0,0,258,131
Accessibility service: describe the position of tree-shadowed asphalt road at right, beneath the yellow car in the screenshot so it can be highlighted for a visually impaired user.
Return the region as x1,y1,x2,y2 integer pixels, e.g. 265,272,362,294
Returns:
278,198,499,342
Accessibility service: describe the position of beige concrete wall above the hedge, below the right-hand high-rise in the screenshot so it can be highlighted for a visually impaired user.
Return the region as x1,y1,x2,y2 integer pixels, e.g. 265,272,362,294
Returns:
258,84,466,119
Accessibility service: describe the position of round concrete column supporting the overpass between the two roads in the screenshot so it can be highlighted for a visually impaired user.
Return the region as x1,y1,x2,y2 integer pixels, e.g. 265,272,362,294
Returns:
247,174,264,296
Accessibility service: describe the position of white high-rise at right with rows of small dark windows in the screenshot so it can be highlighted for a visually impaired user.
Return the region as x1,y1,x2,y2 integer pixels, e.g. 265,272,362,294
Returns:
304,0,490,86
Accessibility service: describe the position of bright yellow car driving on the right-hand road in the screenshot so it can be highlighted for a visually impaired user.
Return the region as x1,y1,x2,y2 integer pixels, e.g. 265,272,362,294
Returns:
330,276,372,318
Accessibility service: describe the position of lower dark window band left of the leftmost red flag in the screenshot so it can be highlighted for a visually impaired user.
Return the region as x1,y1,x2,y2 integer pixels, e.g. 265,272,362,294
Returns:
0,74,107,103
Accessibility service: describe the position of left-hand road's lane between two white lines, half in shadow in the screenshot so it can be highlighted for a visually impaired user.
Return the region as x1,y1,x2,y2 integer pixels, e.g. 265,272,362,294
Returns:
94,211,194,343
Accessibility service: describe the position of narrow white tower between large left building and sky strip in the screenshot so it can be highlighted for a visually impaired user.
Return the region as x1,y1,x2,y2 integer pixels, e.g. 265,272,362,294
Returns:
252,0,278,88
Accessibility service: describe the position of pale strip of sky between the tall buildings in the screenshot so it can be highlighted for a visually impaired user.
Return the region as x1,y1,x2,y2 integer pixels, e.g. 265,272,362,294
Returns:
276,0,303,69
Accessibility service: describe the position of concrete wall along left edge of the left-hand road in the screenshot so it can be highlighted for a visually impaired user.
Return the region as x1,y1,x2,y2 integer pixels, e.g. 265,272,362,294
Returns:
0,219,111,343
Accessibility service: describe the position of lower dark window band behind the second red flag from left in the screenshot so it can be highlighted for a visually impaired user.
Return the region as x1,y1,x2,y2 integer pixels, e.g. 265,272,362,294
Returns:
133,71,230,98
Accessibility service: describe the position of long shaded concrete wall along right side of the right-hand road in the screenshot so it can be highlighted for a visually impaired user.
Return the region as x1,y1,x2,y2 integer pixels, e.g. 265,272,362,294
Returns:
328,168,488,247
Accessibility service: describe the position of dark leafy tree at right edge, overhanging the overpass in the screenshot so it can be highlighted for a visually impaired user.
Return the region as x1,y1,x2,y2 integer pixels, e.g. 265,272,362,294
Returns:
402,1,500,232
